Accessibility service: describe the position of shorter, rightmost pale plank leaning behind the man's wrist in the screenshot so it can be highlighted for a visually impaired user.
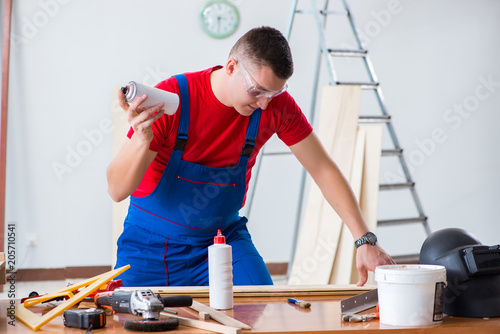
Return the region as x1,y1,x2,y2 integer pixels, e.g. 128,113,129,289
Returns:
349,124,384,284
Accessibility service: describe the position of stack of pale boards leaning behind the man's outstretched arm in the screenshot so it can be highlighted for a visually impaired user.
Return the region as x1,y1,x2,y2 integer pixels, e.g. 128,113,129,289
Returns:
288,85,382,285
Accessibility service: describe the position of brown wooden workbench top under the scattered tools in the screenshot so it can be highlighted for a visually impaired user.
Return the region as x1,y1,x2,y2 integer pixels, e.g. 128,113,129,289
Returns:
0,286,500,334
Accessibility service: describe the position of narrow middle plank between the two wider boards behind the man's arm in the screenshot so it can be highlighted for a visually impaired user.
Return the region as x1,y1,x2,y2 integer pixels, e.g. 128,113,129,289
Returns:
329,127,366,284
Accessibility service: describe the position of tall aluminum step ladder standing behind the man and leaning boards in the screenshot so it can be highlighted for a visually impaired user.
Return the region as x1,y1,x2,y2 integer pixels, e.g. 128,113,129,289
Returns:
248,0,431,263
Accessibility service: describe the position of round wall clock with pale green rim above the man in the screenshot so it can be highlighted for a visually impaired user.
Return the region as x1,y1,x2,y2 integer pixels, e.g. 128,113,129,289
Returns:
200,0,240,38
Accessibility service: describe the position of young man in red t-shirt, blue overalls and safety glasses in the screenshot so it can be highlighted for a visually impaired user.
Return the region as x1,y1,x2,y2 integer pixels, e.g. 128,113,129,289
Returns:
107,27,393,286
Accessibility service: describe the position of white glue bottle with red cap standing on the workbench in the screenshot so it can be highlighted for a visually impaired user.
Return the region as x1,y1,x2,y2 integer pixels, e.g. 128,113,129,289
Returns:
208,230,233,310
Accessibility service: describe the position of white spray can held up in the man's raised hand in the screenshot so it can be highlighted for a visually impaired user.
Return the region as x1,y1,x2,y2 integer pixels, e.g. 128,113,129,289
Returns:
121,81,179,115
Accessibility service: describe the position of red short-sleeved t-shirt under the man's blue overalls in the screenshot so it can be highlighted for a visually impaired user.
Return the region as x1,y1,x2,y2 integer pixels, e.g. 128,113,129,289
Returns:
128,66,312,201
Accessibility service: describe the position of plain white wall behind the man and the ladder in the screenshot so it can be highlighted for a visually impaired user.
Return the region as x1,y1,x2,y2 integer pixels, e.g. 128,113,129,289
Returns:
6,0,500,268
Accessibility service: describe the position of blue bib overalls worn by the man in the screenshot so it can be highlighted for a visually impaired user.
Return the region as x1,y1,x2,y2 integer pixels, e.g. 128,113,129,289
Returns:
116,75,273,286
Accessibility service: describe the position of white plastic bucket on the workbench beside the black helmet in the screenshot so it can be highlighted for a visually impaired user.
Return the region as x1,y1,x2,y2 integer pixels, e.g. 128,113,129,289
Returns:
375,264,446,326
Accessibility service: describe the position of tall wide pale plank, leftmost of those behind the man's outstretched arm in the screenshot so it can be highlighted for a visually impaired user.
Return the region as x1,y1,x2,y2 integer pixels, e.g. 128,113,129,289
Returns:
288,85,361,285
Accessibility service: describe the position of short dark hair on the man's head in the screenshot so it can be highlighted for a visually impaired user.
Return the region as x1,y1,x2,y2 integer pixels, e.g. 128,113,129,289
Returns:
229,26,293,79
